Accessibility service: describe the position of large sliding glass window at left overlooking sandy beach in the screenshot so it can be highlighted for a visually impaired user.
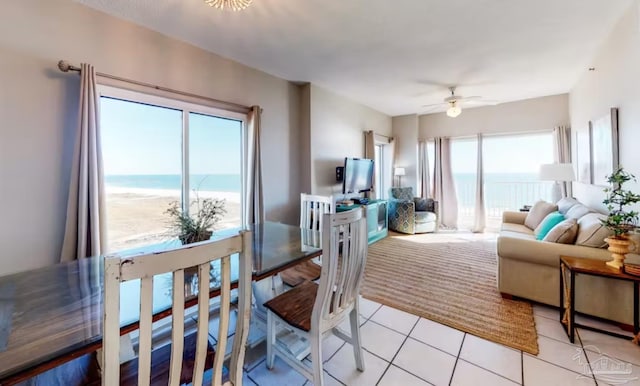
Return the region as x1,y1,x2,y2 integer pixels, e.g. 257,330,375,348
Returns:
100,86,245,252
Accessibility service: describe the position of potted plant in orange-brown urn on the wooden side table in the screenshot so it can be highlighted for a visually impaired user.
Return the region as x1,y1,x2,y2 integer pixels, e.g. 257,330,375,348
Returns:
601,166,640,269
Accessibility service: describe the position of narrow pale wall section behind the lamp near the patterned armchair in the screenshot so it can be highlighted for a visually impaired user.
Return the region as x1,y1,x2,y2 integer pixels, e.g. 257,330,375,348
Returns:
393,115,419,194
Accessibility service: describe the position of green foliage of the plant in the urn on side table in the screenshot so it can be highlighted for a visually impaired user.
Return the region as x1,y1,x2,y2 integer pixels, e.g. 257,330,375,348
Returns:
600,166,640,237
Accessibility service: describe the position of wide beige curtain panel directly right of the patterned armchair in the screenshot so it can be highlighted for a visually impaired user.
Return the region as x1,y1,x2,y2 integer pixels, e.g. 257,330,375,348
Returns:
433,138,458,229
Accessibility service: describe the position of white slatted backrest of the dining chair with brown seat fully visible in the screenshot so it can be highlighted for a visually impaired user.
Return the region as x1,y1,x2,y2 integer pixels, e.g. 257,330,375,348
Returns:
311,208,368,331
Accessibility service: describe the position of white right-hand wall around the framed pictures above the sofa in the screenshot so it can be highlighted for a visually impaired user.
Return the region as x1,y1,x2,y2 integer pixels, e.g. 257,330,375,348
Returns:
570,6,640,209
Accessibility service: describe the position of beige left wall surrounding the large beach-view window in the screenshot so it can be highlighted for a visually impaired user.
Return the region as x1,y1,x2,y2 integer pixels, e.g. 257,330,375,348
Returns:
0,0,301,275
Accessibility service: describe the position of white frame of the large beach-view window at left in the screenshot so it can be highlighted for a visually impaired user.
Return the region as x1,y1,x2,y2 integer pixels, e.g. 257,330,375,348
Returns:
96,84,249,237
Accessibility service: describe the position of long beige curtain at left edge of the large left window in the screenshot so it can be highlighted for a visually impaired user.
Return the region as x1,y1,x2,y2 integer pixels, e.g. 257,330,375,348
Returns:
60,63,107,262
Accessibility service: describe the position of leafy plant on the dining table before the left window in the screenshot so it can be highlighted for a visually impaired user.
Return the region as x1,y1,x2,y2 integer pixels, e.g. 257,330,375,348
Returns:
166,193,227,244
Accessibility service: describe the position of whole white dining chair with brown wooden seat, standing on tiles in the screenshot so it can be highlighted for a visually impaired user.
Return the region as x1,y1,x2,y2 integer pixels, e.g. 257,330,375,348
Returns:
265,209,367,386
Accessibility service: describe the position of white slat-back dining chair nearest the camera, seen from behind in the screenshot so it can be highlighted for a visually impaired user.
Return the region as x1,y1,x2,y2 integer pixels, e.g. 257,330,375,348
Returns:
102,231,252,386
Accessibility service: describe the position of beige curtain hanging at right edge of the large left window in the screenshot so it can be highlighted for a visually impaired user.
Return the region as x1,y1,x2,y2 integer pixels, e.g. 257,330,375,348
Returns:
244,106,264,225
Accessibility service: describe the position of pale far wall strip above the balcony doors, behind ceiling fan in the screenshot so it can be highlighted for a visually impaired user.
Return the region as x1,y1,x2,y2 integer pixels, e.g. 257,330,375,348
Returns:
418,94,569,140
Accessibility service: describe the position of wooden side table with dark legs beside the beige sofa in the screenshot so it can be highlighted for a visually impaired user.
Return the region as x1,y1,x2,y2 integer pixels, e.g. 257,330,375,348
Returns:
560,256,640,344
